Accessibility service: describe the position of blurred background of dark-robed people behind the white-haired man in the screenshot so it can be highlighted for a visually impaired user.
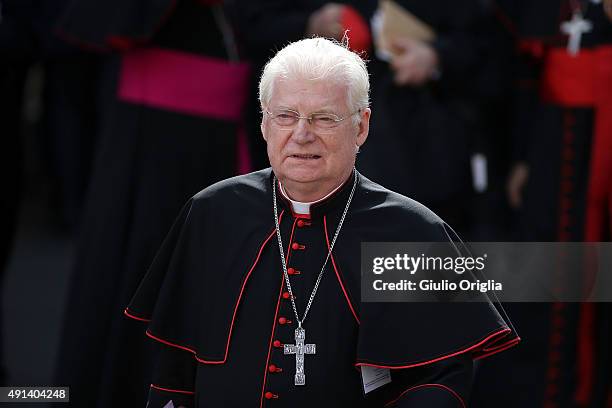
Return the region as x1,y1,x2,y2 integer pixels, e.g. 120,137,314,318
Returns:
0,0,612,408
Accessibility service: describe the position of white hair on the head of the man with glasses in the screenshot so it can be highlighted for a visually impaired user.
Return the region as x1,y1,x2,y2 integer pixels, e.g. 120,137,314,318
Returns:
259,37,370,122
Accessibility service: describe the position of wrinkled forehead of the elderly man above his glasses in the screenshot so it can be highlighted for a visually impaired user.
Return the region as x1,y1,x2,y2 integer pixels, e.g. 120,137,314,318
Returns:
270,77,348,112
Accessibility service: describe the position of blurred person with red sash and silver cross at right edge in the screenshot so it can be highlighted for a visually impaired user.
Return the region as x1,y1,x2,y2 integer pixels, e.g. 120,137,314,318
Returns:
474,0,612,407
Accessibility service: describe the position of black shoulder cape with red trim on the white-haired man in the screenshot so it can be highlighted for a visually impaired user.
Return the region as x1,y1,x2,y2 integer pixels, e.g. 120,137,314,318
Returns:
126,169,519,368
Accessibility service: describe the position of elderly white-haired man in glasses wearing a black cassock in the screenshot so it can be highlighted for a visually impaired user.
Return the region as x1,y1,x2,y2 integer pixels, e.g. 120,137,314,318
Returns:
126,38,518,407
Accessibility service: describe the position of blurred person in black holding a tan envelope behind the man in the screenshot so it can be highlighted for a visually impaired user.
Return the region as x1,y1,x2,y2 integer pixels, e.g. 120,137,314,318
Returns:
359,0,502,237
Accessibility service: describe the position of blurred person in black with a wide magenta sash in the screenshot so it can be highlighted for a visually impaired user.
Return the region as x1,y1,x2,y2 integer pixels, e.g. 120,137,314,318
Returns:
55,0,249,407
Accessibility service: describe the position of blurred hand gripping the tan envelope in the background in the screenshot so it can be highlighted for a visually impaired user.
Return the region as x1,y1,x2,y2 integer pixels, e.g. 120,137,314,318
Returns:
391,38,439,86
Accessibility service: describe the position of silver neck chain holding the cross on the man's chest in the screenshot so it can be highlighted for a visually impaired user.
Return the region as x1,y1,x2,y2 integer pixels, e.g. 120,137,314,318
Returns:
272,170,357,328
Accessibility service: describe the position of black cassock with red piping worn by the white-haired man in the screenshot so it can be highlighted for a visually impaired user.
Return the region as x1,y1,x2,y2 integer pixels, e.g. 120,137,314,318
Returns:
125,169,518,407
